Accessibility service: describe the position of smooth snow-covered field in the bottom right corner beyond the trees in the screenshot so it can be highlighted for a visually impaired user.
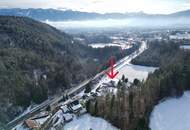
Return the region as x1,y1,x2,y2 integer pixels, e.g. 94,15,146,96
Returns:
149,91,190,130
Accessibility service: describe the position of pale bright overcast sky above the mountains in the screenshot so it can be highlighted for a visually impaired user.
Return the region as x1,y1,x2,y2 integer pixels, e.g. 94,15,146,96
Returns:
0,0,190,14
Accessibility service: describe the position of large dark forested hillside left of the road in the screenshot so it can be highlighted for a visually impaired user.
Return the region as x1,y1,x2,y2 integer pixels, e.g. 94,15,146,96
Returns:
0,16,140,125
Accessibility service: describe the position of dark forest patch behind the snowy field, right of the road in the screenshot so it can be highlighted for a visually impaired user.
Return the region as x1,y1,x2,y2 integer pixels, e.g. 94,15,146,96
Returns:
131,40,181,67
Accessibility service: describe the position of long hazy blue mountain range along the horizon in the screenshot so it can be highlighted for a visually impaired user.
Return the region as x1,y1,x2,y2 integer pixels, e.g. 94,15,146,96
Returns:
0,8,190,21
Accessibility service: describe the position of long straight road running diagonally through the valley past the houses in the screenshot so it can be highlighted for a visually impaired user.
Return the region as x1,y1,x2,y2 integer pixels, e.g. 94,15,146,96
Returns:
6,42,146,130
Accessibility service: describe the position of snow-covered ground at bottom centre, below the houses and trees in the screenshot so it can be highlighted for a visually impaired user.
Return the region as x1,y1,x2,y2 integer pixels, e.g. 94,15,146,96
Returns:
64,114,119,130
